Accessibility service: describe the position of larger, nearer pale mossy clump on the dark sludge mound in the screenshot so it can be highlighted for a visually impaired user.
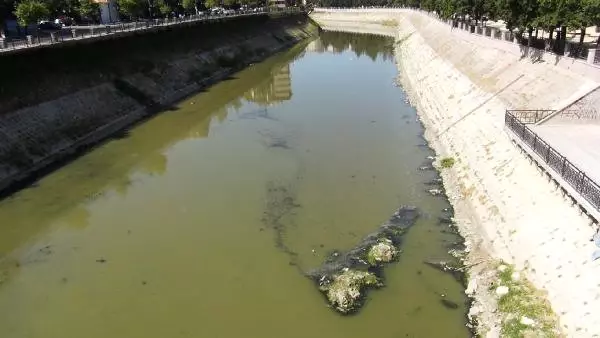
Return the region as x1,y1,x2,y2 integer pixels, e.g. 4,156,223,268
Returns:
321,269,379,313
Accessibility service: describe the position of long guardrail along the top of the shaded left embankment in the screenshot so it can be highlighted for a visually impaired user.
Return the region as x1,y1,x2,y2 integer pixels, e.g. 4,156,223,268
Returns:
0,7,301,55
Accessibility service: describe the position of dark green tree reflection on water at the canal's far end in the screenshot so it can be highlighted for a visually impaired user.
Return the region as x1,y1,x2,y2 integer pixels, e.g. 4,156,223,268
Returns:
307,31,394,61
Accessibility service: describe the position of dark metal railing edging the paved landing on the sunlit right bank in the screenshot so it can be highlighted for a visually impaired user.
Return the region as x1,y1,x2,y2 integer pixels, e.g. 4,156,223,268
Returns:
504,110,600,211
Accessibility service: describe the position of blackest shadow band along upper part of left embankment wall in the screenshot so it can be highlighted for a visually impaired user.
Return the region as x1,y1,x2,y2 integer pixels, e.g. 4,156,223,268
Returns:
0,15,306,114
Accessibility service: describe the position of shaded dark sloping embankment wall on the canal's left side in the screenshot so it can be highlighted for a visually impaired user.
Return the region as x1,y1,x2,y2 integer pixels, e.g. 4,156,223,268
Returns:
0,15,317,191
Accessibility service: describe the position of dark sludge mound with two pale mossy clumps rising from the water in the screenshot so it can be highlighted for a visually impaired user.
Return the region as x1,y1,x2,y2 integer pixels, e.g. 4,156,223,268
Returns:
308,206,419,314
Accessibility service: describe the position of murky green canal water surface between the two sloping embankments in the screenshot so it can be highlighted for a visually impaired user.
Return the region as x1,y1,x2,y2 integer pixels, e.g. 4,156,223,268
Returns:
0,32,469,338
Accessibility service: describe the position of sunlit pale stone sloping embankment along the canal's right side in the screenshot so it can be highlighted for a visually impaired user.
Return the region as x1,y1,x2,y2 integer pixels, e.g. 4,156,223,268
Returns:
312,10,600,337
